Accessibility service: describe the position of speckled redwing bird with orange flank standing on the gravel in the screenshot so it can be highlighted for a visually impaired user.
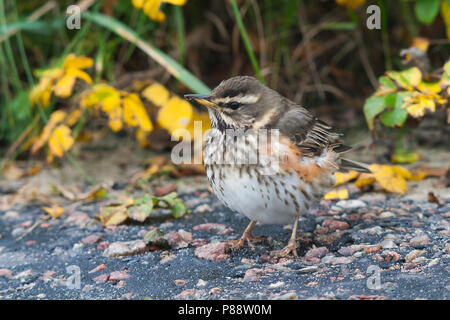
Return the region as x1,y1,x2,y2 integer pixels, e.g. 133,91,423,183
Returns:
185,76,370,256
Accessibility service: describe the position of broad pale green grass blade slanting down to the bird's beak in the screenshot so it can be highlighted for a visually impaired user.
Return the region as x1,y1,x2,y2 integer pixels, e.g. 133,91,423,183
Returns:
83,12,211,94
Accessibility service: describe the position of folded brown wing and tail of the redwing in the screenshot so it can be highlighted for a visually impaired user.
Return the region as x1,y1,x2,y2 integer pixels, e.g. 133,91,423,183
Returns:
275,106,370,172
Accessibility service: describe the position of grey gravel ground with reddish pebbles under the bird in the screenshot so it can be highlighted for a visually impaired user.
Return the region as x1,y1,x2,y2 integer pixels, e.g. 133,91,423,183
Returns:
0,174,450,299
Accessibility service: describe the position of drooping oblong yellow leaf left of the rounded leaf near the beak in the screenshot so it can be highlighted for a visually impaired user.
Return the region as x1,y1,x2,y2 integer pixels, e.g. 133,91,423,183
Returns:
123,93,153,132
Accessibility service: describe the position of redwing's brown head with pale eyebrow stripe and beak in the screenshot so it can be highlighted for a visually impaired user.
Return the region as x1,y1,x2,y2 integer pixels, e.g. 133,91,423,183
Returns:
184,76,283,130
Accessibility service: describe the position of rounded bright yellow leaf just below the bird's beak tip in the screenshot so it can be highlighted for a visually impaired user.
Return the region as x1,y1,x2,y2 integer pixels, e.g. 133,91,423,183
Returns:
158,96,194,133
